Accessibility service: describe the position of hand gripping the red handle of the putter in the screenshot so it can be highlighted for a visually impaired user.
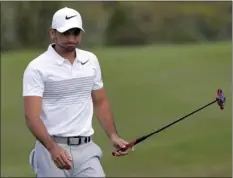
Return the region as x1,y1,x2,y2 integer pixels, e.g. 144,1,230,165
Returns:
111,135,134,156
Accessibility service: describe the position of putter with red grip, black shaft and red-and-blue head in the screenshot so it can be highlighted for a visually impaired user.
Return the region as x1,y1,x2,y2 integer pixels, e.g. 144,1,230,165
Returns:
112,89,226,156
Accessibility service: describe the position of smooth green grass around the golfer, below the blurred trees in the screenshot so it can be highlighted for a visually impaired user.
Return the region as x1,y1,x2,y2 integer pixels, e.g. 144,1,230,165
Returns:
1,43,232,177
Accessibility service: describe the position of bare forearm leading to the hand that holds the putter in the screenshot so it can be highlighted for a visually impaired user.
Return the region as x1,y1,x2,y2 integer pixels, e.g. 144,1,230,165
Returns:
95,100,117,138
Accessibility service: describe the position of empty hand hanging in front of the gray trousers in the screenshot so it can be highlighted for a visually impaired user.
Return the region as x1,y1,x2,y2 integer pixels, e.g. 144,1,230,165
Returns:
48,144,72,170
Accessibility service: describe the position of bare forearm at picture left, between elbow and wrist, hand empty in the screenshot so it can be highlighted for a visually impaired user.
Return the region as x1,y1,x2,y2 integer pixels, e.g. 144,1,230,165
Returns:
26,116,55,150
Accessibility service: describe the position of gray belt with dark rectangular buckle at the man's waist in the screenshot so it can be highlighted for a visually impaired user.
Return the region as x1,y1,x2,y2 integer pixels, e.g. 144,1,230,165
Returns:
52,136,91,146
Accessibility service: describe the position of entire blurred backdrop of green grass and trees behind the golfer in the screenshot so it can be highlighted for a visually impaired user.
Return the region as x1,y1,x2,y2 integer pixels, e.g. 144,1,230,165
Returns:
1,1,232,177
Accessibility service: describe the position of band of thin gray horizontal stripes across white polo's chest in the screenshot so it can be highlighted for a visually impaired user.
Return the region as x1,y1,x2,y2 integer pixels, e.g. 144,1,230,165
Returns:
43,76,94,105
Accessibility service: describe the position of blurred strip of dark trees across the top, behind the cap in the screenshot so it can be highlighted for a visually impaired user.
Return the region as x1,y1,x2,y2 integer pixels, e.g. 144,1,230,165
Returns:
1,1,232,51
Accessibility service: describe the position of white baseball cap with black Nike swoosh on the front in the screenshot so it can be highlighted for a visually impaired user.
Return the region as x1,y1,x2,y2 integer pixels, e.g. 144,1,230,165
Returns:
52,7,85,33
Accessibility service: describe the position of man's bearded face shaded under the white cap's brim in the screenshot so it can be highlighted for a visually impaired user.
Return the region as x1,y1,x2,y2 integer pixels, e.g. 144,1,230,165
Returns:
51,28,81,52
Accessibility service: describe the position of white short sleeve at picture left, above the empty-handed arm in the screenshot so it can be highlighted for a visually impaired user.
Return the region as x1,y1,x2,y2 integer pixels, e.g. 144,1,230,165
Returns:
23,67,44,97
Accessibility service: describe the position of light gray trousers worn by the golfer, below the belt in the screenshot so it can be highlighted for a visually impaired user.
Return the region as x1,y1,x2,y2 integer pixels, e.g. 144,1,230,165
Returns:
29,141,105,177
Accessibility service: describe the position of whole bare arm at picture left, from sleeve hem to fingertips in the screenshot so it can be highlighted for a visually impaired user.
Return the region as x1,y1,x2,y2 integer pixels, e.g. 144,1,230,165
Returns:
24,96,72,170
